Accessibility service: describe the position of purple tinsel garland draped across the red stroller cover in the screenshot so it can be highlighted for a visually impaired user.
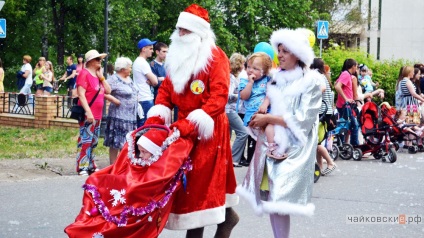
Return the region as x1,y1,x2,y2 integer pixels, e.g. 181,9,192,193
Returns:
82,158,193,227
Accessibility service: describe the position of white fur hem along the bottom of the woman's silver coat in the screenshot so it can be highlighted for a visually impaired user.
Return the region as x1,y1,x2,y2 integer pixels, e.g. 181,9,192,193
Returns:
263,201,315,217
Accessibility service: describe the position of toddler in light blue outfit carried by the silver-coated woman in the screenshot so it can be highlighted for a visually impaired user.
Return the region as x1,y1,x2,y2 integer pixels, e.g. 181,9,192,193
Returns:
239,52,272,138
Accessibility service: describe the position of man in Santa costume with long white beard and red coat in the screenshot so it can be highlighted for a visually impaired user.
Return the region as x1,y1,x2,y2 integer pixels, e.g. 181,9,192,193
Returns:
148,4,239,237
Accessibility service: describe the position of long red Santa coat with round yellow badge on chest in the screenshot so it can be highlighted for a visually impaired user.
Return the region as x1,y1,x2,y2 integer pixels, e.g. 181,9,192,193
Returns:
149,47,238,229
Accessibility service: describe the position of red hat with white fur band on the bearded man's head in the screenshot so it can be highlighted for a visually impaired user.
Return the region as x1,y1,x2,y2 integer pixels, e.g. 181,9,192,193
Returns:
177,4,211,38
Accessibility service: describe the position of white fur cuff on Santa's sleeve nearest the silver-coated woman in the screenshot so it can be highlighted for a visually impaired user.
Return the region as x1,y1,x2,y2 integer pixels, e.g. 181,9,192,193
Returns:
187,109,215,140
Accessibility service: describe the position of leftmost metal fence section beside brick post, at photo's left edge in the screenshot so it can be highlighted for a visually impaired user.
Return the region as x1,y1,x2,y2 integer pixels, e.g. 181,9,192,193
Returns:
0,93,35,116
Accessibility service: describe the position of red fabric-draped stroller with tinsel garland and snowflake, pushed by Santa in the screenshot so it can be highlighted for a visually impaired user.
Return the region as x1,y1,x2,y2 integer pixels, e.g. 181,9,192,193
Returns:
65,121,193,238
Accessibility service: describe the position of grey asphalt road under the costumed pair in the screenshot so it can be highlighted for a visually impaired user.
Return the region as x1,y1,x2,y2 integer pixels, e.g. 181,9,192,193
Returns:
0,153,424,238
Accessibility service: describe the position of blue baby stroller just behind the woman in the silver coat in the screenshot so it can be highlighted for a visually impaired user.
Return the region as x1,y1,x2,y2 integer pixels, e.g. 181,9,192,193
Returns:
326,103,358,160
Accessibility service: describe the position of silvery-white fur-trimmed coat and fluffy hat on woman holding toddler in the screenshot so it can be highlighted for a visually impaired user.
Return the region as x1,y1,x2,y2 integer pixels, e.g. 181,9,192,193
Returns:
237,29,322,220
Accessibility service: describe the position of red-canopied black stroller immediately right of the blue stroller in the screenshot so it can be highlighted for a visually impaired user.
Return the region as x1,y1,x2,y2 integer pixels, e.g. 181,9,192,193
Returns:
353,102,397,163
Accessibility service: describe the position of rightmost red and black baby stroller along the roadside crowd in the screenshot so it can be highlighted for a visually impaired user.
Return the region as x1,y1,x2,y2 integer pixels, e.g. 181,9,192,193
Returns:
380,102,419,154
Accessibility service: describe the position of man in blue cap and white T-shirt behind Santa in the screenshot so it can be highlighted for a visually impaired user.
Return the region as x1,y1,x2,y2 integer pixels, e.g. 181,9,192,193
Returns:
133,38,158,127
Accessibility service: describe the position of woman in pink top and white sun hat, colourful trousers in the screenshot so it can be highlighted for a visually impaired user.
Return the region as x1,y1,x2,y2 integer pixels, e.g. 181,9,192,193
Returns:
76,50,111,176
